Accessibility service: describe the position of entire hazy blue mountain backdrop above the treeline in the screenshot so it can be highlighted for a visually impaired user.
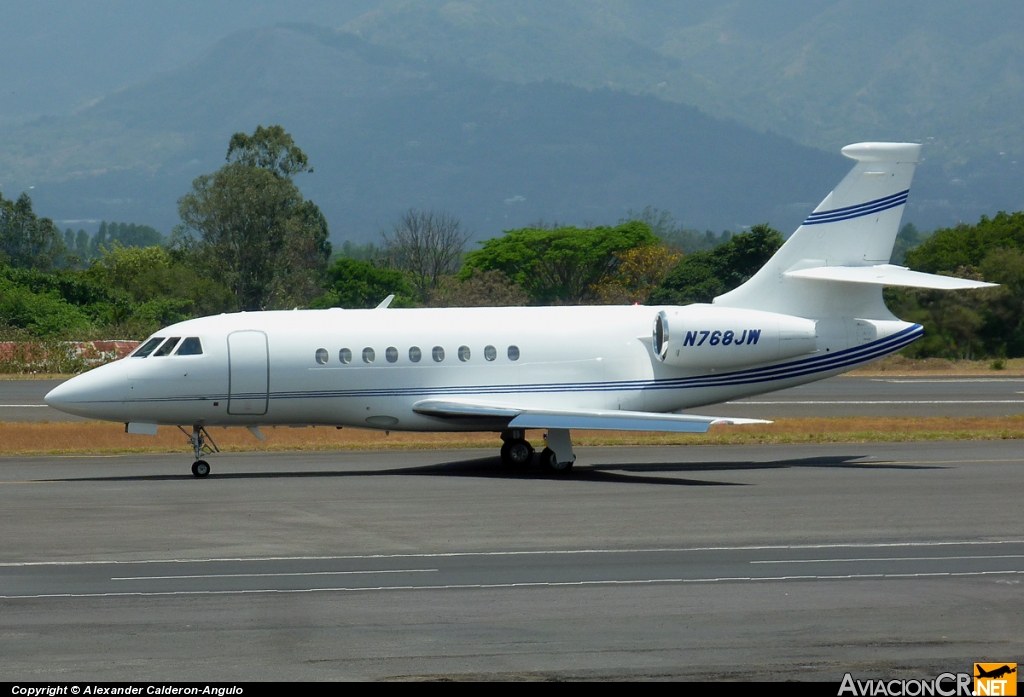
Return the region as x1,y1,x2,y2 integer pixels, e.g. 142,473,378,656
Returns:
0,0,1024,239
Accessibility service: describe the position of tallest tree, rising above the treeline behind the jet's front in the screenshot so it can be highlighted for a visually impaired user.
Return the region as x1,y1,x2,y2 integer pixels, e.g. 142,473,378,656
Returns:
174,126,331,310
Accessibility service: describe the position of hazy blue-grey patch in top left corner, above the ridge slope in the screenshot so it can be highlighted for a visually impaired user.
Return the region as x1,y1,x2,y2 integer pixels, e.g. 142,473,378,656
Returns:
0,0,379,121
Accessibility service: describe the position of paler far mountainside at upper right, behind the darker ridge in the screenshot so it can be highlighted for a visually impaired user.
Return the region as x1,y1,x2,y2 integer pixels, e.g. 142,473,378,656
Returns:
345,0,1024,162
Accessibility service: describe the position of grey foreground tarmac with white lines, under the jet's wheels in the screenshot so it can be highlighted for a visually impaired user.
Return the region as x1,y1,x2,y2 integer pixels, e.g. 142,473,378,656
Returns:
0,441,1024,681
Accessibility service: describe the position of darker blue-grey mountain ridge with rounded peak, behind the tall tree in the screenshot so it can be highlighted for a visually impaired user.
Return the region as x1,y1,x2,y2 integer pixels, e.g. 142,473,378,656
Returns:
0,27,847,239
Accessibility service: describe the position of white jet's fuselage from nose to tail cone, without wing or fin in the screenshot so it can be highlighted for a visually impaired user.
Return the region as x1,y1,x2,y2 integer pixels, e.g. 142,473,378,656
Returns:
47,305,921,431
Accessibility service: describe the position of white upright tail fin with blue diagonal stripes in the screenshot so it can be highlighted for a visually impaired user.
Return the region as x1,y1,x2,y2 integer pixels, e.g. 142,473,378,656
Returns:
715,142,921,319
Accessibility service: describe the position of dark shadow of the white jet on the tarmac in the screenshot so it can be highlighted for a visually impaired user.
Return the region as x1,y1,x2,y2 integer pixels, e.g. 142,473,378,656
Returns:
47,455,945,486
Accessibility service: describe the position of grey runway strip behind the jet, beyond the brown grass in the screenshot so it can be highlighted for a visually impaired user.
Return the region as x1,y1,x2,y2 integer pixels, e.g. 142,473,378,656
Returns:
8,376,1024,422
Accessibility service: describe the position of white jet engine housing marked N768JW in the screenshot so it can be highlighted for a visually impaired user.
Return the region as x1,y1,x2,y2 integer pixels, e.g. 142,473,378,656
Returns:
653,305,817,368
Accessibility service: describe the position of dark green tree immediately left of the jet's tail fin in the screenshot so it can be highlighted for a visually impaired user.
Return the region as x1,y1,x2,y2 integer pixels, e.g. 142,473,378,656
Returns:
647,223,783,305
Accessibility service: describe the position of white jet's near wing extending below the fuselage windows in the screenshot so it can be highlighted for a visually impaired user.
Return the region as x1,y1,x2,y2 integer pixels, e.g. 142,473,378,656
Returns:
413,399,771,433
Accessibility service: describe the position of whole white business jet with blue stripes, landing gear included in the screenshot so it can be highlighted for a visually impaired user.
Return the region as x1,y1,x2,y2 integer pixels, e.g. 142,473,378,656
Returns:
46,142,991,477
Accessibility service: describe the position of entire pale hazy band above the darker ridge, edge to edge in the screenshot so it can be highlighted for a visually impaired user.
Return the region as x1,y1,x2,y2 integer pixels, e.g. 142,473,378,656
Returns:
8,0,1024,164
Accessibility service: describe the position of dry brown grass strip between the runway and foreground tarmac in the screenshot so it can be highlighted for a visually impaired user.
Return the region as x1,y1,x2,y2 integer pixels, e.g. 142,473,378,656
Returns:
8,417,1024,454
